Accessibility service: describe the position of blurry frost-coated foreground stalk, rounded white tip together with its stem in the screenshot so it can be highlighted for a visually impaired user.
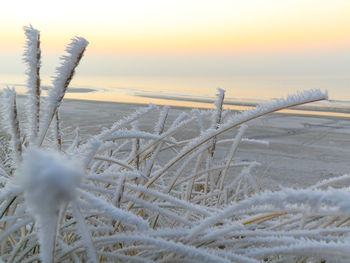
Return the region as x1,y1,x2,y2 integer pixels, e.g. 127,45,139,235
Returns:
15,148,82,262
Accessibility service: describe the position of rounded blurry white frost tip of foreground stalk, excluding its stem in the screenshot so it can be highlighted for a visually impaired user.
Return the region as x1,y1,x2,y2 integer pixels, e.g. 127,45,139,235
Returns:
15,148,82,217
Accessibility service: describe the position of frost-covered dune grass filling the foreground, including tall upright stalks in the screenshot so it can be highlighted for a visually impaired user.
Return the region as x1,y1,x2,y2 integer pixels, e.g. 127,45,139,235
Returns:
0,27,350,262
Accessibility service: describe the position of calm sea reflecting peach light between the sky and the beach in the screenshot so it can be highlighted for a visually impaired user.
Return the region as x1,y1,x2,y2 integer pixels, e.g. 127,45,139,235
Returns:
0,74,350,116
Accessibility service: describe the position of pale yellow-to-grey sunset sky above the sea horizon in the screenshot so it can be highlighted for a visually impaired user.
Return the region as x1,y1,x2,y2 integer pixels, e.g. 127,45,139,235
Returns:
0,0,350,102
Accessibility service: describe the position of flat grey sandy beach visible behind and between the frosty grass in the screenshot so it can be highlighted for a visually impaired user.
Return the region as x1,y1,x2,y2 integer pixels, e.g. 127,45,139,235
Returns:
13,97,342,189
